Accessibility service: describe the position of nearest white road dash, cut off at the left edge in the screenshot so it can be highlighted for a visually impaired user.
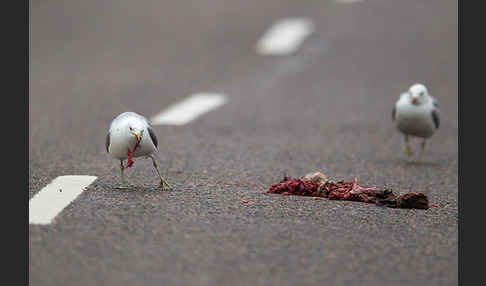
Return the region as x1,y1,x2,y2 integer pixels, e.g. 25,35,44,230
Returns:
29,176,97,224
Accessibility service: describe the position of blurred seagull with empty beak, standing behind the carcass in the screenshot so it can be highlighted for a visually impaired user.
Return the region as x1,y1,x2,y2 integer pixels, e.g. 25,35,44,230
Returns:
392,83,440,163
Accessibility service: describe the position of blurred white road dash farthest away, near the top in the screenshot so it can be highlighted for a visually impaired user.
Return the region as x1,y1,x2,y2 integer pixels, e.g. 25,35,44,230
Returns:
256,18,314,55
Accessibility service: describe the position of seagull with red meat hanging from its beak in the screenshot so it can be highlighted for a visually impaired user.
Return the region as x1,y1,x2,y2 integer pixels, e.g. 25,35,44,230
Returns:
105,112,172,190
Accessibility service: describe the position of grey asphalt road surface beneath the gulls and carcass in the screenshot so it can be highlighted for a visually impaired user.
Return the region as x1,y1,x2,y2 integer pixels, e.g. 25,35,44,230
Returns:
29,0,458,286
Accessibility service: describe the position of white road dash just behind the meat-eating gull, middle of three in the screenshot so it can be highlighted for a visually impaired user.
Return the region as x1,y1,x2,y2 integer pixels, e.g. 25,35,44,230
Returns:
150,93,227,125
